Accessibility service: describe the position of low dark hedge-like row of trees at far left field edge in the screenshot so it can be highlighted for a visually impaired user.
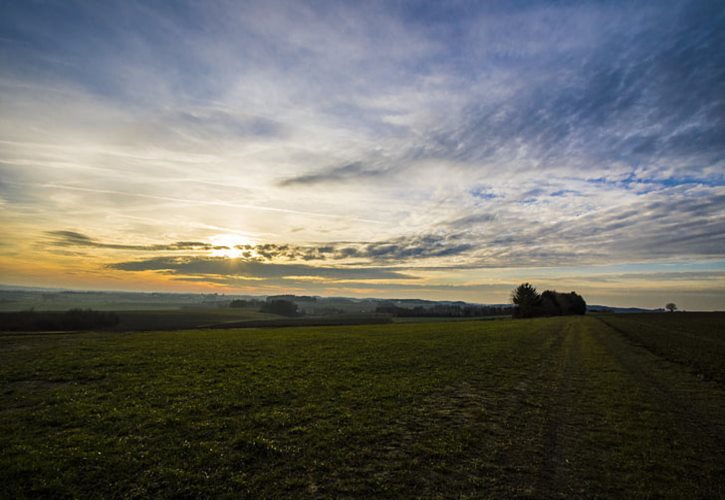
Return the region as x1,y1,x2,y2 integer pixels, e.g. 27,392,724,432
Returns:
0,309,119,332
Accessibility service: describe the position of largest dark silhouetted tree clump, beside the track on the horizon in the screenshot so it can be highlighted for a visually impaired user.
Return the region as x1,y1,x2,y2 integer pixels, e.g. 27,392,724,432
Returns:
511,283,587,318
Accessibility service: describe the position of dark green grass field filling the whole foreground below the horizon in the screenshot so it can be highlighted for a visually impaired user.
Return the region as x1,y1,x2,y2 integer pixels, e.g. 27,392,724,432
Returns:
0,314,725,498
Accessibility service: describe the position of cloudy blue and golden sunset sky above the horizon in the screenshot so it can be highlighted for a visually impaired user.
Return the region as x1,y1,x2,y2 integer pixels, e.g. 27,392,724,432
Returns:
0,0,725,310
